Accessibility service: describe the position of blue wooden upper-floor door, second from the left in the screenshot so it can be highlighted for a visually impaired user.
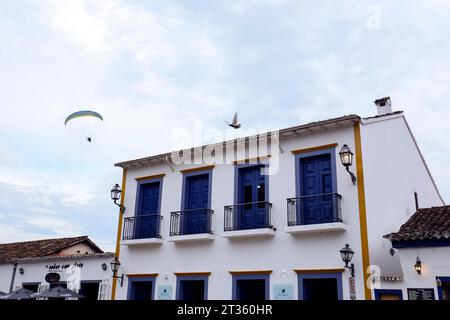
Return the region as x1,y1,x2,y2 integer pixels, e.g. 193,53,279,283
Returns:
183,174,209,234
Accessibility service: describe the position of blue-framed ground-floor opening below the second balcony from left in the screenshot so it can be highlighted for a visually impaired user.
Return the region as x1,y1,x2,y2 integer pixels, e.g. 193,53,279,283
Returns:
176,275,208,301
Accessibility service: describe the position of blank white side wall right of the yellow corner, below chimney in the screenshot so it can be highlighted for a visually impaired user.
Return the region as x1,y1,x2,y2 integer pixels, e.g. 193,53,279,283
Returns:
361,114,443,282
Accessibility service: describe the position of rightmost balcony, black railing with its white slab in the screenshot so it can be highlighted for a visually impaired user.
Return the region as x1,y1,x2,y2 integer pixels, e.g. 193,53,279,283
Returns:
286,193,346,233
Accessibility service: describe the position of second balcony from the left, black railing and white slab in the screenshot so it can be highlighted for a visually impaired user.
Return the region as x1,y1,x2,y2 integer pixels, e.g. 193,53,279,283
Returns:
169,208,214,242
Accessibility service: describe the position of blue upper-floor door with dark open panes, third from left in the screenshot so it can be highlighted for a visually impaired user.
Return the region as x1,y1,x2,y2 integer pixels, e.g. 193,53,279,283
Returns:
238,166,267,229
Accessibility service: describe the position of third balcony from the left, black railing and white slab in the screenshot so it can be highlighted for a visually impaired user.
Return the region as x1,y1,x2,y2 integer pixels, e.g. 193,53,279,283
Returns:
224,201,275,238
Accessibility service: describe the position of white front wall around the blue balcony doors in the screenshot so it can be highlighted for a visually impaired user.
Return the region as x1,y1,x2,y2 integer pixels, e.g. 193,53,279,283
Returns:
117,122,370,299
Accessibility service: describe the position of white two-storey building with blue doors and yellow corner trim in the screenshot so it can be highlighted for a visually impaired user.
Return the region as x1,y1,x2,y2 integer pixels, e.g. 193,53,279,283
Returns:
112,98,444,299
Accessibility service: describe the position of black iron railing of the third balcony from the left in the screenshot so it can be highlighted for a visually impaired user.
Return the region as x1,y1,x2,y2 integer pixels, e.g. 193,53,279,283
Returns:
224,201,273,231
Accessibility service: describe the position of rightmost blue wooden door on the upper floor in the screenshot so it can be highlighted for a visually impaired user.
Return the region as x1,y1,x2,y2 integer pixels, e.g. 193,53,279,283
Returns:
298,154,335,224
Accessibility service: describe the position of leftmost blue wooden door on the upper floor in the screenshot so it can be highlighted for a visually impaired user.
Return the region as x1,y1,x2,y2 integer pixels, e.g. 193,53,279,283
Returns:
135,182,160,238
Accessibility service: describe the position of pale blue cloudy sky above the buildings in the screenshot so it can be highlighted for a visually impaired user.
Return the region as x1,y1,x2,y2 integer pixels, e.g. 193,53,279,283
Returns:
0,0,450,250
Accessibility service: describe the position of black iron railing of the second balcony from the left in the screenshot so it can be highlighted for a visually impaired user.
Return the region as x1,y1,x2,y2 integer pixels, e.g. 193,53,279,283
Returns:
170,208,214,236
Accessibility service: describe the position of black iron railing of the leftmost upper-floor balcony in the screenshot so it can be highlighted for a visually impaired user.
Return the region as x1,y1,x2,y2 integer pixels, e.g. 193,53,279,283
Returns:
123,214,162,240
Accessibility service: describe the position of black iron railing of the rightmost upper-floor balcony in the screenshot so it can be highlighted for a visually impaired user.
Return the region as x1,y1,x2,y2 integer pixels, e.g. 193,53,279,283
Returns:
287,193,342,226
